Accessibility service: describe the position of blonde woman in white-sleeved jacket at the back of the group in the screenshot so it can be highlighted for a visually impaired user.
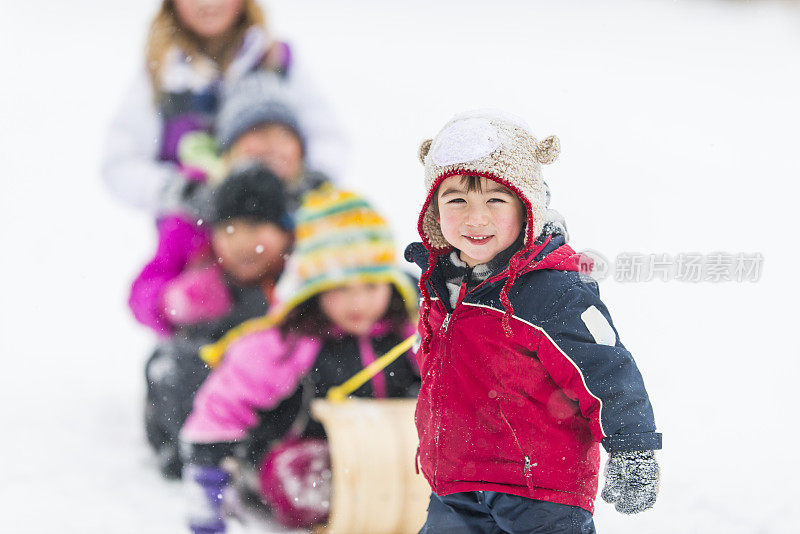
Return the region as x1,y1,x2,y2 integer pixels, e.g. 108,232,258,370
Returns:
103,0,346,216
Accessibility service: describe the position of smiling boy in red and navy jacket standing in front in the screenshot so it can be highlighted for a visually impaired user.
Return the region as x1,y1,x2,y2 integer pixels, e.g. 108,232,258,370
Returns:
406,112,661,534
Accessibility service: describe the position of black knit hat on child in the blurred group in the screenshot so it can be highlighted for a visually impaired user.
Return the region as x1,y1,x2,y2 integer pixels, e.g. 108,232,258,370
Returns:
213,164,292,230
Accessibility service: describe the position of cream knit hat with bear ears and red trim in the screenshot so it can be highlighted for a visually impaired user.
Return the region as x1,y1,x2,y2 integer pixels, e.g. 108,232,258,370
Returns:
418,110,561,251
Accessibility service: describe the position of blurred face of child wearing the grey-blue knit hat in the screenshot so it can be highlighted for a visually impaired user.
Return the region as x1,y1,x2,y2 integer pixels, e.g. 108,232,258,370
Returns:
230,124,303,183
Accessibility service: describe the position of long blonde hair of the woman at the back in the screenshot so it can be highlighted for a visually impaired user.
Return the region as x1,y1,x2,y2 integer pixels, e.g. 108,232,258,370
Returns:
145,0,266,92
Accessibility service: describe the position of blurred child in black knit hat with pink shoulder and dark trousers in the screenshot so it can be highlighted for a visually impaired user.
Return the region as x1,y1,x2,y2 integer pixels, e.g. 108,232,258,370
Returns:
145,166,292,477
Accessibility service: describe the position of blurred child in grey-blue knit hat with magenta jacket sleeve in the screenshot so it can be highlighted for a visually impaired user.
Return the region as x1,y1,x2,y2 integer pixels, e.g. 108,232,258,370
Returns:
128,72,326,336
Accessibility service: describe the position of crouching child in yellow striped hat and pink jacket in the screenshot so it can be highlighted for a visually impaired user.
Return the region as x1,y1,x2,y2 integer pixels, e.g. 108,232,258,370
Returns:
181,187,419,533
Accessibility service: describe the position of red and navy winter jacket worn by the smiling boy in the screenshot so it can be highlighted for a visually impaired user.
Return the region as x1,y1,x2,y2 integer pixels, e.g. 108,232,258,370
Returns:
406,235,661,512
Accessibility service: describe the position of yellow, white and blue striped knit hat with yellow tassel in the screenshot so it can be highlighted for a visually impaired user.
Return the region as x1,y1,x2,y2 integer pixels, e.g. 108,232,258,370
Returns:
201,185,418,365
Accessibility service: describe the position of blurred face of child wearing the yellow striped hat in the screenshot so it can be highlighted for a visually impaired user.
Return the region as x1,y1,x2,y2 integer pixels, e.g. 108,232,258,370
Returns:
319,282,392,336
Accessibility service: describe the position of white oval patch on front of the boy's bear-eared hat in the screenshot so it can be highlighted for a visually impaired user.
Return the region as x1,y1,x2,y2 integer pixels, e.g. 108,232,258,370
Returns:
431,119,500,167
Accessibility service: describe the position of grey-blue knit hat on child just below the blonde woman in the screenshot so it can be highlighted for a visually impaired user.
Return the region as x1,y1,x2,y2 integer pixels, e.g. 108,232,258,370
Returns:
216,71,305,151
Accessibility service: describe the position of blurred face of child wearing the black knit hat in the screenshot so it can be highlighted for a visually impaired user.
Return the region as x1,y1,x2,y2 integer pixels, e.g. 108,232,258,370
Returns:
212,219,291,284
